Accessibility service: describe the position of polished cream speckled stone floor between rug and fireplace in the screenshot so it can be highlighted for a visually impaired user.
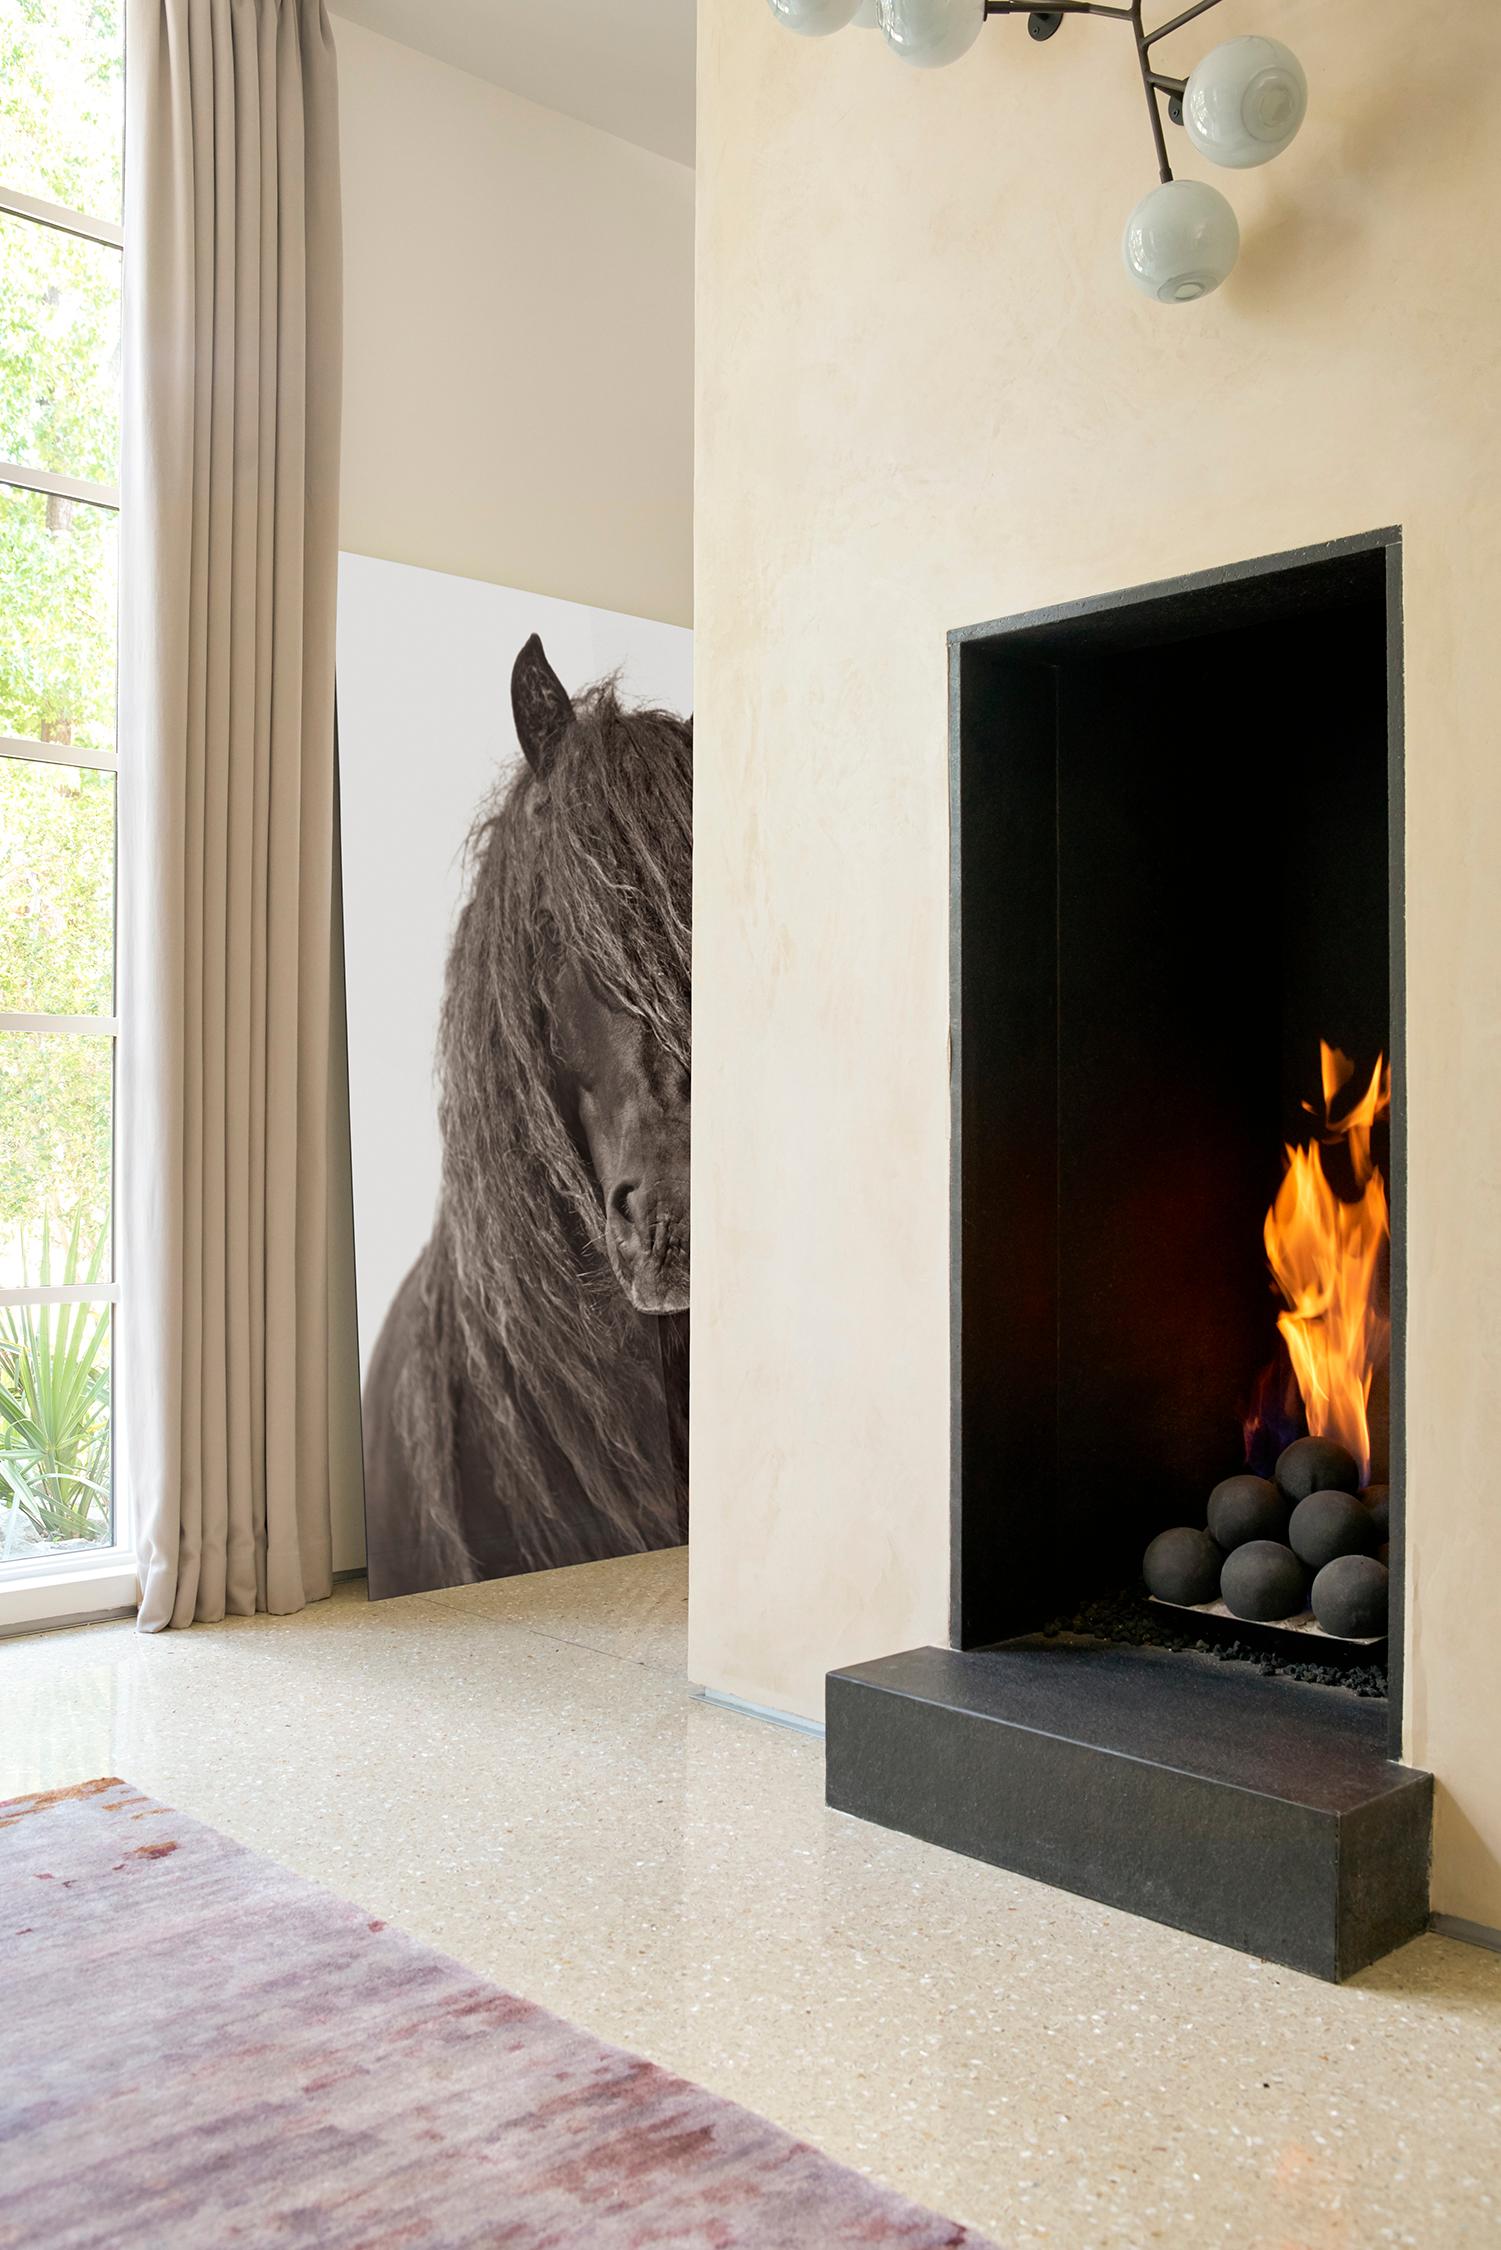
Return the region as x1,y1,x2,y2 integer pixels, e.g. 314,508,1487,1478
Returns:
0,1555,1501,2250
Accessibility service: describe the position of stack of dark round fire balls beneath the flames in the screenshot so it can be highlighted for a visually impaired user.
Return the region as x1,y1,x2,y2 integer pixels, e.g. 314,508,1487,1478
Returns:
1141,1438,1391,1640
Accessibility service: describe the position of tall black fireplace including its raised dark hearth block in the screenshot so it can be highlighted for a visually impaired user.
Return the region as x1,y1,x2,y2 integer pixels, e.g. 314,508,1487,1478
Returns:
828,531,1431,1976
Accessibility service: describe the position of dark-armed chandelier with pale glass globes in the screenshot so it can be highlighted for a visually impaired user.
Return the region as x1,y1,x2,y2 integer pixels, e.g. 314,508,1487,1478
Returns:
767,0,1307,304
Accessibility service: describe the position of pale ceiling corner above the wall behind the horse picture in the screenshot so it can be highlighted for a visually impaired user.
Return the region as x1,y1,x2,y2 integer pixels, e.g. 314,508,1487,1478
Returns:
333,0,693,164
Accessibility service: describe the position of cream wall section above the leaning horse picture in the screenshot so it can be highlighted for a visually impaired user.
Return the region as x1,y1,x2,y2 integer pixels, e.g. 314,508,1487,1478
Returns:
335,18,693,626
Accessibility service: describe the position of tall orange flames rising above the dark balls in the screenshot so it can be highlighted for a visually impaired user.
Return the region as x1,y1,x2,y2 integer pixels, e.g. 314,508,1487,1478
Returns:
1265,1042,1391,1483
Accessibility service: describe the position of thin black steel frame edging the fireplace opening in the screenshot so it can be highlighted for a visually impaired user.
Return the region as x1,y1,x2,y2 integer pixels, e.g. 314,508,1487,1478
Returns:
947,527,1406,1760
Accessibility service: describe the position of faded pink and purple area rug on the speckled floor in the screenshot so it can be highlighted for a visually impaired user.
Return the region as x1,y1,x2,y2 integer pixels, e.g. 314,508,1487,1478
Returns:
0,1780,992,2250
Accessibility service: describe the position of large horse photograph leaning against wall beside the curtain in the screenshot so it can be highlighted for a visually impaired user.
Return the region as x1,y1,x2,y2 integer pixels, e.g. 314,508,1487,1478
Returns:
338,556,693,1598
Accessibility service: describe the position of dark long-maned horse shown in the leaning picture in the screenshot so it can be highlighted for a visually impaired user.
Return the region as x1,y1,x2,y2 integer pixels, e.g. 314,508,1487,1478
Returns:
365,635,693,1595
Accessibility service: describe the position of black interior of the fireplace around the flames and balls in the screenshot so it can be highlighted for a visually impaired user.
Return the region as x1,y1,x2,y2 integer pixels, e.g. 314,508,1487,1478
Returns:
952,533,1402,1694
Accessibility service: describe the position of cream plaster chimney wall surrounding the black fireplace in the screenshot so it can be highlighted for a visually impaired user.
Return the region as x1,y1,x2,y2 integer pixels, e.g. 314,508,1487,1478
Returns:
691,0,1501,1924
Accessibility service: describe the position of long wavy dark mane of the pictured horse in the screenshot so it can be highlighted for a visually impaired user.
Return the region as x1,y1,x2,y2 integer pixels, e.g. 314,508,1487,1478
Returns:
394,677,693,1584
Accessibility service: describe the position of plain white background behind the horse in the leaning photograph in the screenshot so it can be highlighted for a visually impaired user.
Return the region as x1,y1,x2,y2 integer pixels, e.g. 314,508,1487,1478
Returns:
338,556,693,1413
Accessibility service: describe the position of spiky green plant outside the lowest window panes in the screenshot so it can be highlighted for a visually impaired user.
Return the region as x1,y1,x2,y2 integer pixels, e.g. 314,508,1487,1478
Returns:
0,1213,110,1562
